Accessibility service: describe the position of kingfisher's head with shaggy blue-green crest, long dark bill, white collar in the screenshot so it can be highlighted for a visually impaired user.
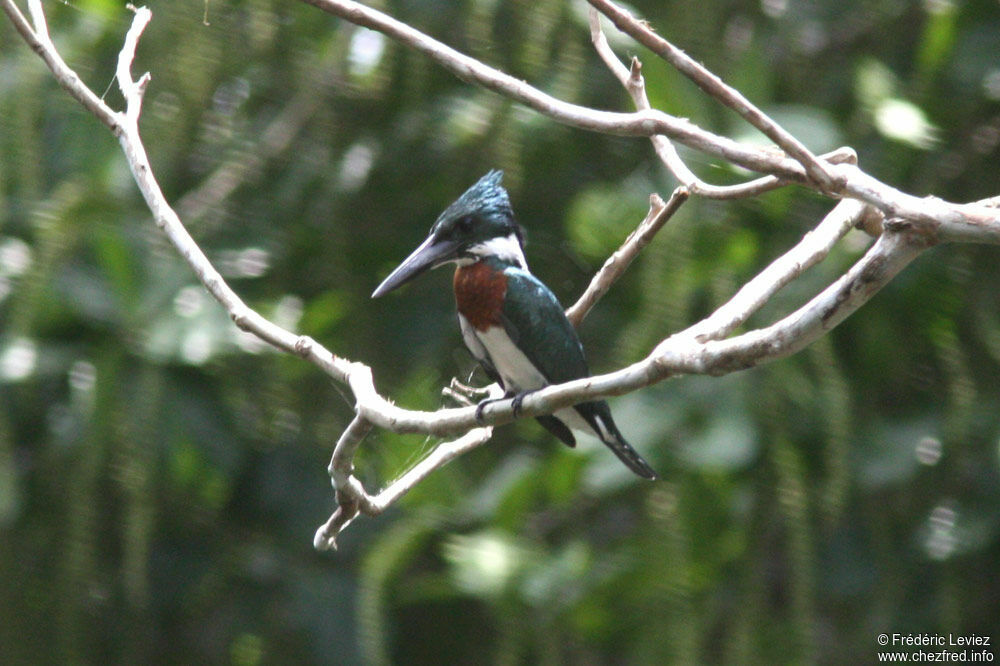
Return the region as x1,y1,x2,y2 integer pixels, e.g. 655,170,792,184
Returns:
372,169,526,298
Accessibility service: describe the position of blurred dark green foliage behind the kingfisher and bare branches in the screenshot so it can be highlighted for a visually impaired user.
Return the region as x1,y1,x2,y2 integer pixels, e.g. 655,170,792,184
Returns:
0,0,1000,665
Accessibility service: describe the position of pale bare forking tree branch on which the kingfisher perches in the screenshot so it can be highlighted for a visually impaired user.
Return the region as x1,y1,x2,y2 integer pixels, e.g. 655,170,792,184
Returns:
7,0,1000,549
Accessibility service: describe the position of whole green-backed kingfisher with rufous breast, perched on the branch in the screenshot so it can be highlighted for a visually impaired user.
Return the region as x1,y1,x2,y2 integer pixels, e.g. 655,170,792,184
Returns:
372,170,657,479
